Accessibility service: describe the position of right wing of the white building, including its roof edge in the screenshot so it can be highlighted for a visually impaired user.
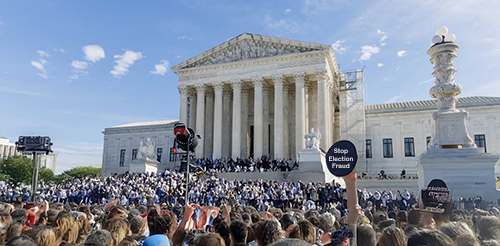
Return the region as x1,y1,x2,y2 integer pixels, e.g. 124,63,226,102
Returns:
364,97,500,175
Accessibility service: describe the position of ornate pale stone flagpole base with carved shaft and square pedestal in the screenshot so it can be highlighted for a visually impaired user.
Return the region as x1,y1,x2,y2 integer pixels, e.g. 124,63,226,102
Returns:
417,27,500,202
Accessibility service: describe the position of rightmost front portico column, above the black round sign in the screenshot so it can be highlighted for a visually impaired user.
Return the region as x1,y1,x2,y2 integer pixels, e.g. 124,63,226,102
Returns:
316,71,330,151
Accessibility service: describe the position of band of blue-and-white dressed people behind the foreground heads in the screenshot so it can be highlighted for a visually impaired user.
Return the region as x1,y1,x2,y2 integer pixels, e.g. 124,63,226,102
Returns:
0,171,416,211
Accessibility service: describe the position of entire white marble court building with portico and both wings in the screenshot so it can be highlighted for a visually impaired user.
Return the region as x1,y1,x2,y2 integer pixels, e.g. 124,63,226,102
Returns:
102,33,500,178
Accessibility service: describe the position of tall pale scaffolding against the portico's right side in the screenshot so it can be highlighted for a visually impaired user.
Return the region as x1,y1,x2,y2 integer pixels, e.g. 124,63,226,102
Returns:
339,69,368,172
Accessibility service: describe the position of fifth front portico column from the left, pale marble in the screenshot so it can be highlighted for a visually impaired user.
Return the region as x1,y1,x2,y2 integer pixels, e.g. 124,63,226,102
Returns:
252,78,264,159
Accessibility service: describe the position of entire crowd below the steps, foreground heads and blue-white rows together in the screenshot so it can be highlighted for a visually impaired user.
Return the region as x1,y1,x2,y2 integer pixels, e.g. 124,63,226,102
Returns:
0,171,500,246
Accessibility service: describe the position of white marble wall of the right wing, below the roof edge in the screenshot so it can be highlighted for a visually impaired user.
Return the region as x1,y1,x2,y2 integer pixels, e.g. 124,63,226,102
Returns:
359,105,500,175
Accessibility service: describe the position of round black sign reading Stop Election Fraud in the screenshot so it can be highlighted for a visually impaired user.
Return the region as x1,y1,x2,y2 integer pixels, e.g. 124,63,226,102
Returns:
326,140,358,177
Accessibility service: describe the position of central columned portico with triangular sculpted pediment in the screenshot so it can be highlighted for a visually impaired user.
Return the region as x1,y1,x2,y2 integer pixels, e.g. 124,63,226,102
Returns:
172,33,340,159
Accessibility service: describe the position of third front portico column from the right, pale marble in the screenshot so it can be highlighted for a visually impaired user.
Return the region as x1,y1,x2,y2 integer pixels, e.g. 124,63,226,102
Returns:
273,75,284,159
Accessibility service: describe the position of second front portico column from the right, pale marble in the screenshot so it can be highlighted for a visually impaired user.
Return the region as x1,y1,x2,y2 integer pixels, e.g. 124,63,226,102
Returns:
293,73,306,155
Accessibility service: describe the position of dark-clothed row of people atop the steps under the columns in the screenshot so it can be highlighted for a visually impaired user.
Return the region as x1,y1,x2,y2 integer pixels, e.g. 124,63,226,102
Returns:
196,156,298,173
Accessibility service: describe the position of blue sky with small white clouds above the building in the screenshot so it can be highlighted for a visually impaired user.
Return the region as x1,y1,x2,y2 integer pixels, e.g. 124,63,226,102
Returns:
0,0,500,172
